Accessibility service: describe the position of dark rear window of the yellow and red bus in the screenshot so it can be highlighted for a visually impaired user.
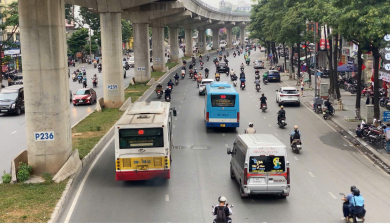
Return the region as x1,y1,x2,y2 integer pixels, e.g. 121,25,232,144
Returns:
119,128,164,149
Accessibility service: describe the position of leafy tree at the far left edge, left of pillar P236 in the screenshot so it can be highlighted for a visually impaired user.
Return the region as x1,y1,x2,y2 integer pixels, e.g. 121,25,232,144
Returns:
0,2,19,84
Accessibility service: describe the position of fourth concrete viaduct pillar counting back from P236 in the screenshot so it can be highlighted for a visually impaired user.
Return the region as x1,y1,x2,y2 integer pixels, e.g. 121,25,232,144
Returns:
152,26,165,71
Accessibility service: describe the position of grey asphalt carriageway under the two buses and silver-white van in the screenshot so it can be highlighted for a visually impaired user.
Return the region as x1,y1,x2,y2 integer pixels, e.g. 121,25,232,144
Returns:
59,50,390,223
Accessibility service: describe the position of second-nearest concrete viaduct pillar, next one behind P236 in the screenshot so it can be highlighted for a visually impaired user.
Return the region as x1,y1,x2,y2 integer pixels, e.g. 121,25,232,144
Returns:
100,12,125,108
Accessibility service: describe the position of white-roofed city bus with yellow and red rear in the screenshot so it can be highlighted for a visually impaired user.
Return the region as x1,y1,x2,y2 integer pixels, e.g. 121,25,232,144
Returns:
115,101,173,181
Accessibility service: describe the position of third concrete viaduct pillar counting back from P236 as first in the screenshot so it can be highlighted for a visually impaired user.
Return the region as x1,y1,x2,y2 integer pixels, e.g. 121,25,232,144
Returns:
133,23,154,82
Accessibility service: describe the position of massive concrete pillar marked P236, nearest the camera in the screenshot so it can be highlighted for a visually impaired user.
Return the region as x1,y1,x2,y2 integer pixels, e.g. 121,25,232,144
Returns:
19,0,72,175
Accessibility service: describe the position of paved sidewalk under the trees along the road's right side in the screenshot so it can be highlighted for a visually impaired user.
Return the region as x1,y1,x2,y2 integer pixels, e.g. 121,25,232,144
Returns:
281,73,390,170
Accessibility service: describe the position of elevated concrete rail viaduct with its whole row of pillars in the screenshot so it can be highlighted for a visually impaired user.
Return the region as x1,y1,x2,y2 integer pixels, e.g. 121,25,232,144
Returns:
19,0,250,174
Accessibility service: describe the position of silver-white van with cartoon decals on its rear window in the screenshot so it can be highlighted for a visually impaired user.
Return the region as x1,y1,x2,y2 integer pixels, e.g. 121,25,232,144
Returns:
227,134,290,198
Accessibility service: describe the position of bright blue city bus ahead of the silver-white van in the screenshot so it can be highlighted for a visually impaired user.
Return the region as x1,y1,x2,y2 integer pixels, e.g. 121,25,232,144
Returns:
204,82,240,128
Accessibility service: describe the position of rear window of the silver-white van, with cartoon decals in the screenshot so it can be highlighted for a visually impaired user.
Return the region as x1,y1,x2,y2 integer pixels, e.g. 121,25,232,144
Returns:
249,156,286,173
